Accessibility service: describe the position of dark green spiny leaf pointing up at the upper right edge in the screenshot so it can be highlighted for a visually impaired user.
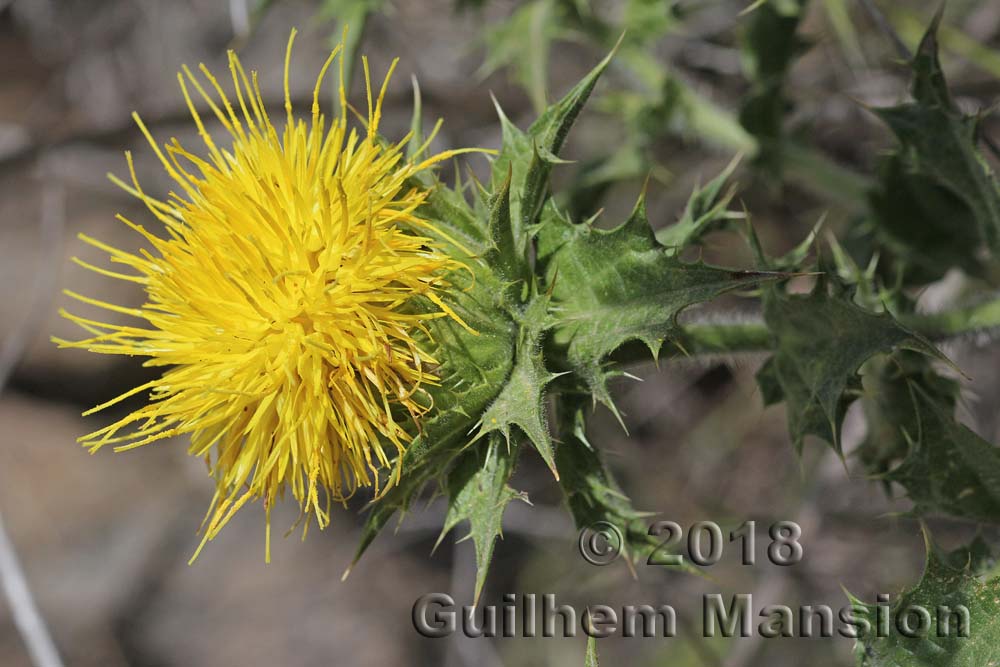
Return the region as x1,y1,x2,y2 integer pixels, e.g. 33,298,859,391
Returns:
875,14,1000,261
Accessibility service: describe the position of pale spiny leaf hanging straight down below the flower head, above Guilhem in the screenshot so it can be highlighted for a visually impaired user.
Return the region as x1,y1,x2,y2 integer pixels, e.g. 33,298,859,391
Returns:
438,435,527,604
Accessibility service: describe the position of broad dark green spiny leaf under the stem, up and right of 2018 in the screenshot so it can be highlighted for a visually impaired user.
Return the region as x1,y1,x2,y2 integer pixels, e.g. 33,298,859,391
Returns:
757,279,940,453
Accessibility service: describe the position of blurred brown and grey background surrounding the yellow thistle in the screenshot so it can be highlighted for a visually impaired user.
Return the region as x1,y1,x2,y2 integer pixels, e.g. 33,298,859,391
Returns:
0,0,1000,667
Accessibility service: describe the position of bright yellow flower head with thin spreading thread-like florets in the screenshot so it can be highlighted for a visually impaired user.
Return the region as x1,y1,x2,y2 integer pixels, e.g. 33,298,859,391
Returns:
56,31,476,558
